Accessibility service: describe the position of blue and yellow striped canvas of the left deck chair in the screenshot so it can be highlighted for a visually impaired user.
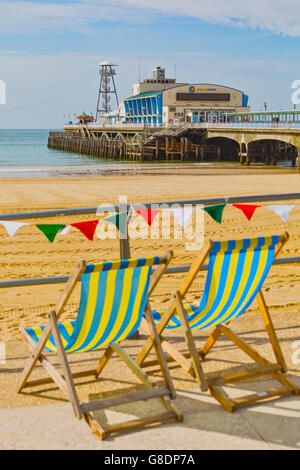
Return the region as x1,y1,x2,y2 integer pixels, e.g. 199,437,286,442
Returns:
26,256,161,353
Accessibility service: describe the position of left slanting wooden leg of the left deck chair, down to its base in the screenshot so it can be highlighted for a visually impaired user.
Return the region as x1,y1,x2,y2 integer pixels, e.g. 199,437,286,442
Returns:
49,311,83,419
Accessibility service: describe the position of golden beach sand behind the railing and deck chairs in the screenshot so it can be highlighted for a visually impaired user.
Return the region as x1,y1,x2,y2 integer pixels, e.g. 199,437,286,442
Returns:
0,167,300,407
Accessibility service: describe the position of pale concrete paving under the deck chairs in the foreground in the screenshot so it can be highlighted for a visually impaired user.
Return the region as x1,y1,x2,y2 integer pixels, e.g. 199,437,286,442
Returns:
0,378,300,451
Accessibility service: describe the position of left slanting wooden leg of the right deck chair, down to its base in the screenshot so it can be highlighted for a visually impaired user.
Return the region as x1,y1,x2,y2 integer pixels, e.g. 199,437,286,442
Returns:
174,291,208,392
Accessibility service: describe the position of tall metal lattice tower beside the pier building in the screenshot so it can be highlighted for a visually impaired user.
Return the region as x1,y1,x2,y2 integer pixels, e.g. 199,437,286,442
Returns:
96,61,119,121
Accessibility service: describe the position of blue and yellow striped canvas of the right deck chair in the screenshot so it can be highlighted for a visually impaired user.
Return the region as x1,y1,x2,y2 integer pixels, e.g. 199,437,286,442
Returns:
153,235,279,330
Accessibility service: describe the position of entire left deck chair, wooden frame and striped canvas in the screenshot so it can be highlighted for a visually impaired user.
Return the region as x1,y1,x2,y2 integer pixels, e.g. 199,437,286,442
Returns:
19,251,182,439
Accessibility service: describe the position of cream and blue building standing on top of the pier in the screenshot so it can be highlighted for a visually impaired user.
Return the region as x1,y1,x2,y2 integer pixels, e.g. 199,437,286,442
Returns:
106,67,250,127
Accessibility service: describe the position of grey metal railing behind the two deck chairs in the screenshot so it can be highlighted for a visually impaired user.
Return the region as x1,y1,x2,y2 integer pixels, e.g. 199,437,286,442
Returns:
0,193,300,288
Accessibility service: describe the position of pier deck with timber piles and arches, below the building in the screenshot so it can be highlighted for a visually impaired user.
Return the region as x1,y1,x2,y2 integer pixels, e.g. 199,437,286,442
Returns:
48,123,300,170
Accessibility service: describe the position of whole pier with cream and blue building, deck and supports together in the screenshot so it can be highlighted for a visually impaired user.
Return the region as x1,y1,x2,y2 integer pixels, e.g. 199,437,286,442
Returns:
48,61,300,166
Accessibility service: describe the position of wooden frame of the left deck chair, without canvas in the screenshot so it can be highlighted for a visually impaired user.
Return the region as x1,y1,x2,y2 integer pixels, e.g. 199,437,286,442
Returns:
18,250,183,440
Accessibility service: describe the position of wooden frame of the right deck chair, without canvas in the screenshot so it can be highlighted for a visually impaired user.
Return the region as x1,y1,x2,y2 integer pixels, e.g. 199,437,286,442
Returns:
137,232,300,412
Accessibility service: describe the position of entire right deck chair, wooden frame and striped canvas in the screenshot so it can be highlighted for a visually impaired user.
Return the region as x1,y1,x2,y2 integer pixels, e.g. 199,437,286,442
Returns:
137,233,299,411
